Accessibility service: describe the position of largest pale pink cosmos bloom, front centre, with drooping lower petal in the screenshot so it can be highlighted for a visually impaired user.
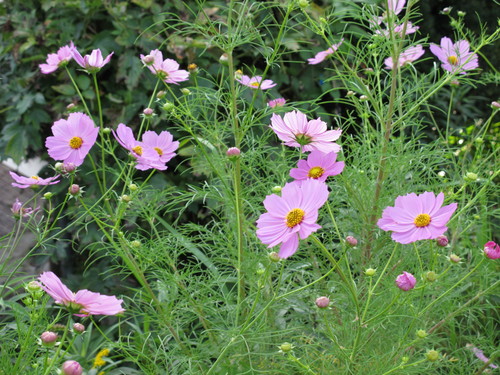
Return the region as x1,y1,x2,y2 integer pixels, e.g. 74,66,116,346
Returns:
257,179,328,258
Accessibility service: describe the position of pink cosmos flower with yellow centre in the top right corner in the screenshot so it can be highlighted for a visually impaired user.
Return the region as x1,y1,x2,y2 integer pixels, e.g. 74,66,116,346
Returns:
430,37,479,74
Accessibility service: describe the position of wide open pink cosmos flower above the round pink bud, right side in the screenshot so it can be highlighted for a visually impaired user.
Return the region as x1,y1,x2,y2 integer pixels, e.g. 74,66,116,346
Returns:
377,192,457,244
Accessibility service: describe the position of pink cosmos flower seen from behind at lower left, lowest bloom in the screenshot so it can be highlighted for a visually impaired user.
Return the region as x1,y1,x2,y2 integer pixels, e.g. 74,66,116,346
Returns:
38,272,125,316
